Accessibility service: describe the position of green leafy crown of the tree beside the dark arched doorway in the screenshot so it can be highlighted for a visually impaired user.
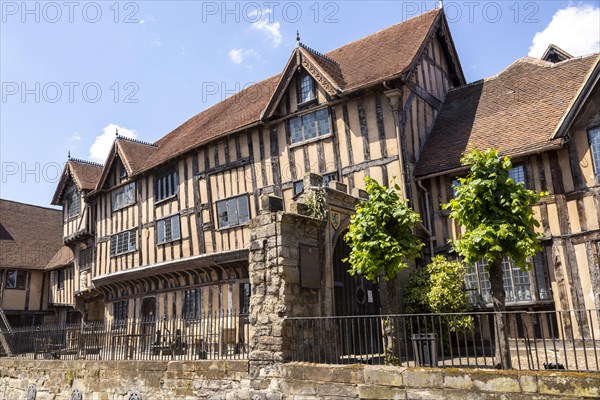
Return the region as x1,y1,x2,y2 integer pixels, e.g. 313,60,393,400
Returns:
344,176,423,282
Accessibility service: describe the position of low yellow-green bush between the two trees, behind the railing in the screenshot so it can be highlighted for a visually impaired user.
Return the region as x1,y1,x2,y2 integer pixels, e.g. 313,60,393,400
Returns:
404,256,472,331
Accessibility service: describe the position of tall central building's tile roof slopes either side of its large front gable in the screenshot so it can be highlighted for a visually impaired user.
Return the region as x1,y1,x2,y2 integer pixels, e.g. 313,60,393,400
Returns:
137,9,442,172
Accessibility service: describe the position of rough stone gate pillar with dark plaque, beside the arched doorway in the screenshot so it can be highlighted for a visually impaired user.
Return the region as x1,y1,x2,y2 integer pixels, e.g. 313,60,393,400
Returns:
248,196,325,399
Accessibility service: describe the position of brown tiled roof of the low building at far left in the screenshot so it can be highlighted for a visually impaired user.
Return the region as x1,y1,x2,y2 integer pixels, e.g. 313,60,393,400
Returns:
0,199,63,270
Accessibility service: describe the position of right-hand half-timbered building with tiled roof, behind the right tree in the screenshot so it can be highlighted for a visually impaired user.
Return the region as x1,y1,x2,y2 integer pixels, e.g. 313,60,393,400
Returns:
415,46,600,337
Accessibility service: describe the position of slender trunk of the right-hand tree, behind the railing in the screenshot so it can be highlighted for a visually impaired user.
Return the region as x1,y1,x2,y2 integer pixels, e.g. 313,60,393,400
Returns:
489,260,512,369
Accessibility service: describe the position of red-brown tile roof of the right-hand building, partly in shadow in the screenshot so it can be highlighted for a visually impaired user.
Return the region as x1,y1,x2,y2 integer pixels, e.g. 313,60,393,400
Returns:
415,54,600,176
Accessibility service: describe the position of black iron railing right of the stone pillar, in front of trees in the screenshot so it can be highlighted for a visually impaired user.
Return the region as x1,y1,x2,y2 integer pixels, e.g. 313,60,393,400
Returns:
285,310,600,371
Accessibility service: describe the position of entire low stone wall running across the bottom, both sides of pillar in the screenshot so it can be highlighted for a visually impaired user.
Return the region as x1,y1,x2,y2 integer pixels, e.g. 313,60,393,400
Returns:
0,359,600,400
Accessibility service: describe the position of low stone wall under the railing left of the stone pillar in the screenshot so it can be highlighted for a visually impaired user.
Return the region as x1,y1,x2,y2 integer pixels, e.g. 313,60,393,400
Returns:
0,359,249,400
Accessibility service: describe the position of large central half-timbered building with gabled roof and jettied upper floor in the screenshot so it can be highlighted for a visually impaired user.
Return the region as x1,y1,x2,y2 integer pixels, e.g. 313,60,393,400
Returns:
53,10,465,319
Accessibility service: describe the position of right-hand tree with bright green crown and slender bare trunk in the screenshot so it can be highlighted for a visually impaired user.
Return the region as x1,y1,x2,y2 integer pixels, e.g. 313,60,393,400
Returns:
444,150,541,369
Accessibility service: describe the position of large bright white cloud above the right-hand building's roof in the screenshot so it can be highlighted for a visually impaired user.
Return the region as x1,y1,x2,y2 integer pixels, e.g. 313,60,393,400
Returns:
529,4,600,58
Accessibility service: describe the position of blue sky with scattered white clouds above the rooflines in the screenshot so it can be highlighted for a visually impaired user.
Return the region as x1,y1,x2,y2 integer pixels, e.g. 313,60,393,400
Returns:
0,0,600,206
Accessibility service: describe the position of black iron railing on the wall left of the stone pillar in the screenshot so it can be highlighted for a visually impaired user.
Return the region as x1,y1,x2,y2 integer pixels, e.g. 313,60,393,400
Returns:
2,312,249,360
